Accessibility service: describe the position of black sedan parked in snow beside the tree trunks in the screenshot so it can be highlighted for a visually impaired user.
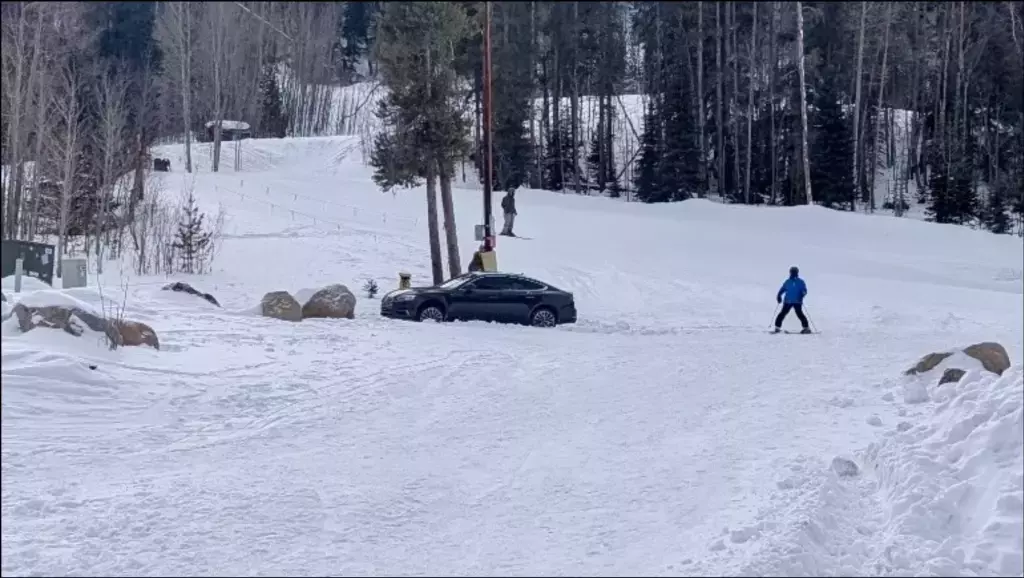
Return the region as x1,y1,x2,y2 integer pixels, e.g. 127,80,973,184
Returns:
381,273,577,327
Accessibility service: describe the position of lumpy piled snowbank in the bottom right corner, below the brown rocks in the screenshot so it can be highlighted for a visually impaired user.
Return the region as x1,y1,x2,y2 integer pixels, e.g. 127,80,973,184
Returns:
737,360,1024,576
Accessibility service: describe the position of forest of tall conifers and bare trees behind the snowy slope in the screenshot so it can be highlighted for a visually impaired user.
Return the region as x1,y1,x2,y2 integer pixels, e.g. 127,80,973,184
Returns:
0,1,1024,240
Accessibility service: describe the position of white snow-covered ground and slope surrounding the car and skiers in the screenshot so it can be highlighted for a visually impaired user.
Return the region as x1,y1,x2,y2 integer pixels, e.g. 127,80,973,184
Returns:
2,137,1024,576
